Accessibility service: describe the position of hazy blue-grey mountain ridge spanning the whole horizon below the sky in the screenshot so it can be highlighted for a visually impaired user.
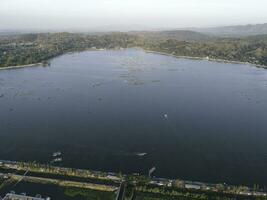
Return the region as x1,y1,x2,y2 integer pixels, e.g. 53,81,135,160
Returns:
0,23,267,38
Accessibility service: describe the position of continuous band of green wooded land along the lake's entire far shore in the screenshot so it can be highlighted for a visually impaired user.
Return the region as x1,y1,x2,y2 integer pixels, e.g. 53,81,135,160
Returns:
0,32,267,67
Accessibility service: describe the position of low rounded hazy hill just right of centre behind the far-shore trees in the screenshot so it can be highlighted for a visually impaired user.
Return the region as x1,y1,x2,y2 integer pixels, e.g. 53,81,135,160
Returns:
129,30,213,42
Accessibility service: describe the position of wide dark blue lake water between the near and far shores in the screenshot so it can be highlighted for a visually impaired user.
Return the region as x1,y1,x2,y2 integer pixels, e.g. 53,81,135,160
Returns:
0,49,267,185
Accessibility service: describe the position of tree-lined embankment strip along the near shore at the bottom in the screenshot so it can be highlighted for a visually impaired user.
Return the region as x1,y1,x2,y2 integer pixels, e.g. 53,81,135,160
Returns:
0,160,267,199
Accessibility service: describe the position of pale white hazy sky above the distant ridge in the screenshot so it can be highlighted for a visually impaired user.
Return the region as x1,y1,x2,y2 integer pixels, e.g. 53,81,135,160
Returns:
0,0,267,30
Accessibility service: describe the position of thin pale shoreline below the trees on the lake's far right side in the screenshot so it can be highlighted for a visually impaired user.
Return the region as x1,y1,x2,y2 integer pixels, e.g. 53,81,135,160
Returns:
143,49,267,69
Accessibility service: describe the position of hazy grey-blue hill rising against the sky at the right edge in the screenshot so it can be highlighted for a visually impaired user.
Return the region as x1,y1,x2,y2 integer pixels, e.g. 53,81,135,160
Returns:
194,23,267,37
